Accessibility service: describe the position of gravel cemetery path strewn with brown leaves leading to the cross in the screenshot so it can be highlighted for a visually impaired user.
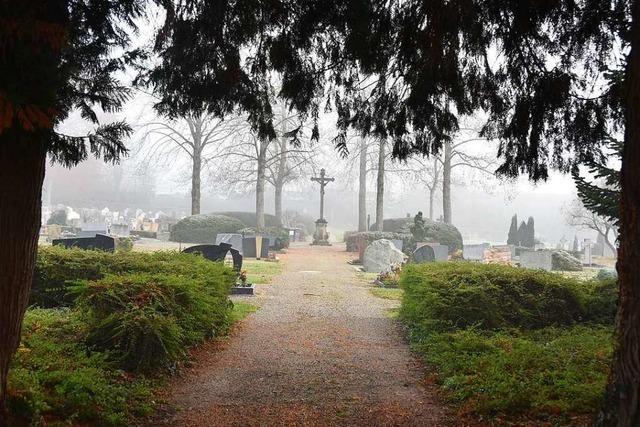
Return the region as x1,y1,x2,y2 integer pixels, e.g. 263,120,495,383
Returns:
159,245,448,426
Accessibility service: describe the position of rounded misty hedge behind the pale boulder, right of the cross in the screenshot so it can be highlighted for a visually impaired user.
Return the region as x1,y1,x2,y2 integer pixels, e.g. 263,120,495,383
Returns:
344,218,462,254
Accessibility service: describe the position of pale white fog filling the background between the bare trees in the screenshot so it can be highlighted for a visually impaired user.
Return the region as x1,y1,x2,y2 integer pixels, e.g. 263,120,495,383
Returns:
43,95,595,246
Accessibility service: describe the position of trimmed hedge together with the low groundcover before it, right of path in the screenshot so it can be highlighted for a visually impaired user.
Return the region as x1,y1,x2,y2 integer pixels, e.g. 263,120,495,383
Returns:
400,262,617,424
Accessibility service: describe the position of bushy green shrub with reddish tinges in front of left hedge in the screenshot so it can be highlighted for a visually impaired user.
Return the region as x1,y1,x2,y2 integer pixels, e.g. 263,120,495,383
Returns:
78,272,233,371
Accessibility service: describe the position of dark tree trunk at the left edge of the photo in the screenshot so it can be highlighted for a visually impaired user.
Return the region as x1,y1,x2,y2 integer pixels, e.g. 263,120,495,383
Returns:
0,135,46,425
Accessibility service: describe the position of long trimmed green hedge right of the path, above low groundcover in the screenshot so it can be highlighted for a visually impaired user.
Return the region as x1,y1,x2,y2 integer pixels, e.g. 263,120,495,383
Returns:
400,262,615,330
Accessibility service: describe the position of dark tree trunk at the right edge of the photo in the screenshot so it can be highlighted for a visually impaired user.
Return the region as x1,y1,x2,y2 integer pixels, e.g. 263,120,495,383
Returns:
597,0,640,427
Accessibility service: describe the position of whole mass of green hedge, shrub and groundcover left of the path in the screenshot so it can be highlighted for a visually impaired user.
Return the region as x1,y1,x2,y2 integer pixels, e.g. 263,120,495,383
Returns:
8,247,240,426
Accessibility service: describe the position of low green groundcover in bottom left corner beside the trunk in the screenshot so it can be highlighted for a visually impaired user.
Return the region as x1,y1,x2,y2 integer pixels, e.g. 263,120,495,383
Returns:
7,309,153,426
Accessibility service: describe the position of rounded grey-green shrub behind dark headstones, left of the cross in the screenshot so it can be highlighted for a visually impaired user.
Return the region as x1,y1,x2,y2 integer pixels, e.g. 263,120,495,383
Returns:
170,214,245,244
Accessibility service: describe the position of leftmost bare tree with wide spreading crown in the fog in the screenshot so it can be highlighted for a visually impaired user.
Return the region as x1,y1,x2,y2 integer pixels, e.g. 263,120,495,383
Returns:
139,113,246,215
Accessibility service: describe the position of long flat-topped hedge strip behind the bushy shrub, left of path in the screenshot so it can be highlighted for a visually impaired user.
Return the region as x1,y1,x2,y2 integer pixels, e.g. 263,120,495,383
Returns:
30,246,235,307
